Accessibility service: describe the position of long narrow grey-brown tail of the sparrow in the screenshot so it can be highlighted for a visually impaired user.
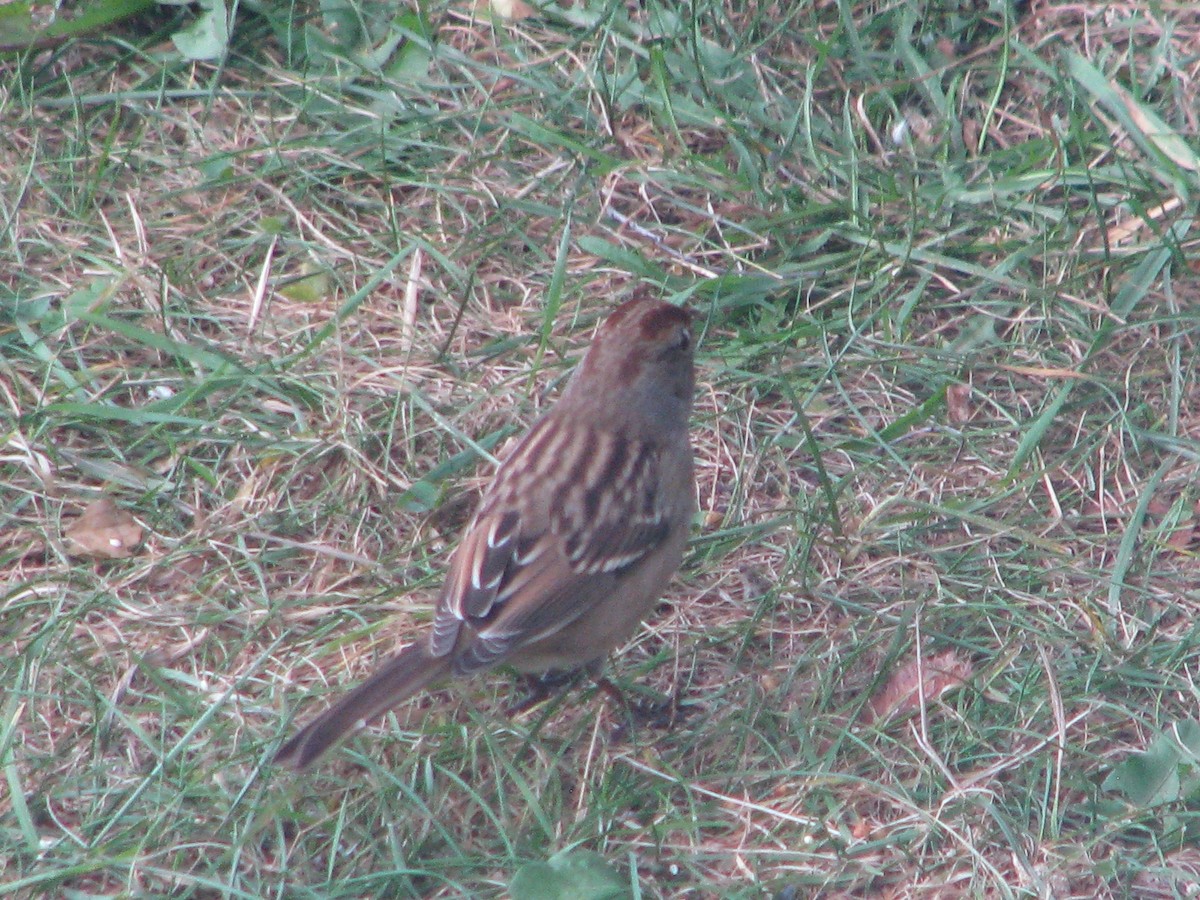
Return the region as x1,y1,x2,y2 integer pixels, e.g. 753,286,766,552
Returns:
275,641,450,772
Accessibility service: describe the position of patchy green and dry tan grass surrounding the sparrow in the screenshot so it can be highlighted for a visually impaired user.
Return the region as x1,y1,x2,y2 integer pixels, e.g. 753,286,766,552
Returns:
0,0,1200,898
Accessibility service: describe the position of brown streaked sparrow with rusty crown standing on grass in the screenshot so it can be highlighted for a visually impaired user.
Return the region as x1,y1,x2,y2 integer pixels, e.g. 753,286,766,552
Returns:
275,294,696,772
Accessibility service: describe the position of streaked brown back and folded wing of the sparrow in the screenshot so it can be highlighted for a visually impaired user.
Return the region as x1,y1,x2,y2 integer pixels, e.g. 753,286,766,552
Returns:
430,418,668,672
